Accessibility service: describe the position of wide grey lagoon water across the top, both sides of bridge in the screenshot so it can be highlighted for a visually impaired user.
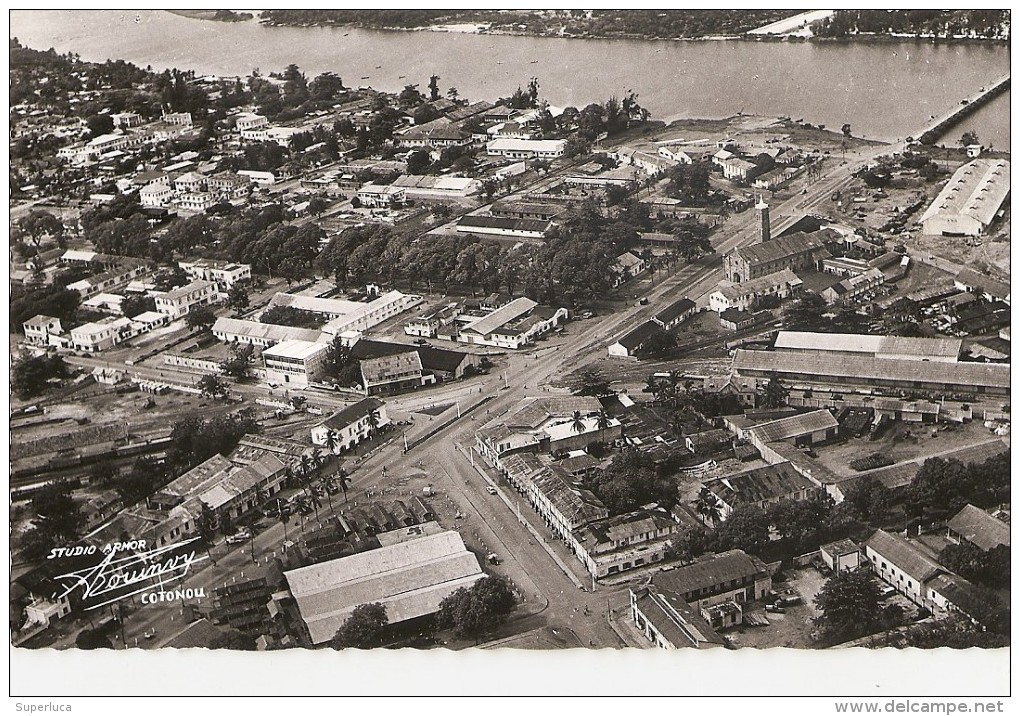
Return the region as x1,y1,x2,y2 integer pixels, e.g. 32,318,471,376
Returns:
10,10,1010,148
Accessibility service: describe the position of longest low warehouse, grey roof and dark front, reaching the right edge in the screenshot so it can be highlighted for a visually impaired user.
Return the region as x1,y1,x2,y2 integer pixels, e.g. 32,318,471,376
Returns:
733,349,1010,398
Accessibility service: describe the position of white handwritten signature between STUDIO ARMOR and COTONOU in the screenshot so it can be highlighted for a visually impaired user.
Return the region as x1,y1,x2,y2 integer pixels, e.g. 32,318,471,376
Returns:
56,538,208,611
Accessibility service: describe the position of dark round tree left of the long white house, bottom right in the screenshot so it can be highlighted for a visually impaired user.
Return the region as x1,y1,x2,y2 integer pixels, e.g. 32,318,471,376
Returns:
815,568,881,643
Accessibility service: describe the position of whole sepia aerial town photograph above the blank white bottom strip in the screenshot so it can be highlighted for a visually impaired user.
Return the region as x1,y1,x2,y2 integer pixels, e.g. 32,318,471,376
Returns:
8,9,1011,703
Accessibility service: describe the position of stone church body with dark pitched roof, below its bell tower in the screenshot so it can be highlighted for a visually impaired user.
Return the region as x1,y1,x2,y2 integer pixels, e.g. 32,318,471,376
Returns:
723,229,838,284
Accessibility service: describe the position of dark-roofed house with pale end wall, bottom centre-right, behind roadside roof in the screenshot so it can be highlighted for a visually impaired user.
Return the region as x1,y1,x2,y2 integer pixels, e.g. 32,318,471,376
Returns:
651,550,772,610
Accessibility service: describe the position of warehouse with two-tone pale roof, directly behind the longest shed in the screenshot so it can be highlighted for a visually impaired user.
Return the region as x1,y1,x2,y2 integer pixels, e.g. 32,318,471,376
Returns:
775,330,963,363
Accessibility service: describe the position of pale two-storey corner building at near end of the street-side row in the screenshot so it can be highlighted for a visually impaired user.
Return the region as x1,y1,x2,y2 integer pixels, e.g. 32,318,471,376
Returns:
572,510,680,578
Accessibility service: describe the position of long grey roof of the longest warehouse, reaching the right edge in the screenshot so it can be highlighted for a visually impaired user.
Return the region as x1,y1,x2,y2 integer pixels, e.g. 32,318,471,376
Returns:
733,349,1010,390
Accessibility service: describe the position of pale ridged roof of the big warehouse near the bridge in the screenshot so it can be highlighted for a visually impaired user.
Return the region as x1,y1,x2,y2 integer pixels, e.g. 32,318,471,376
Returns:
919,159,1010,226
